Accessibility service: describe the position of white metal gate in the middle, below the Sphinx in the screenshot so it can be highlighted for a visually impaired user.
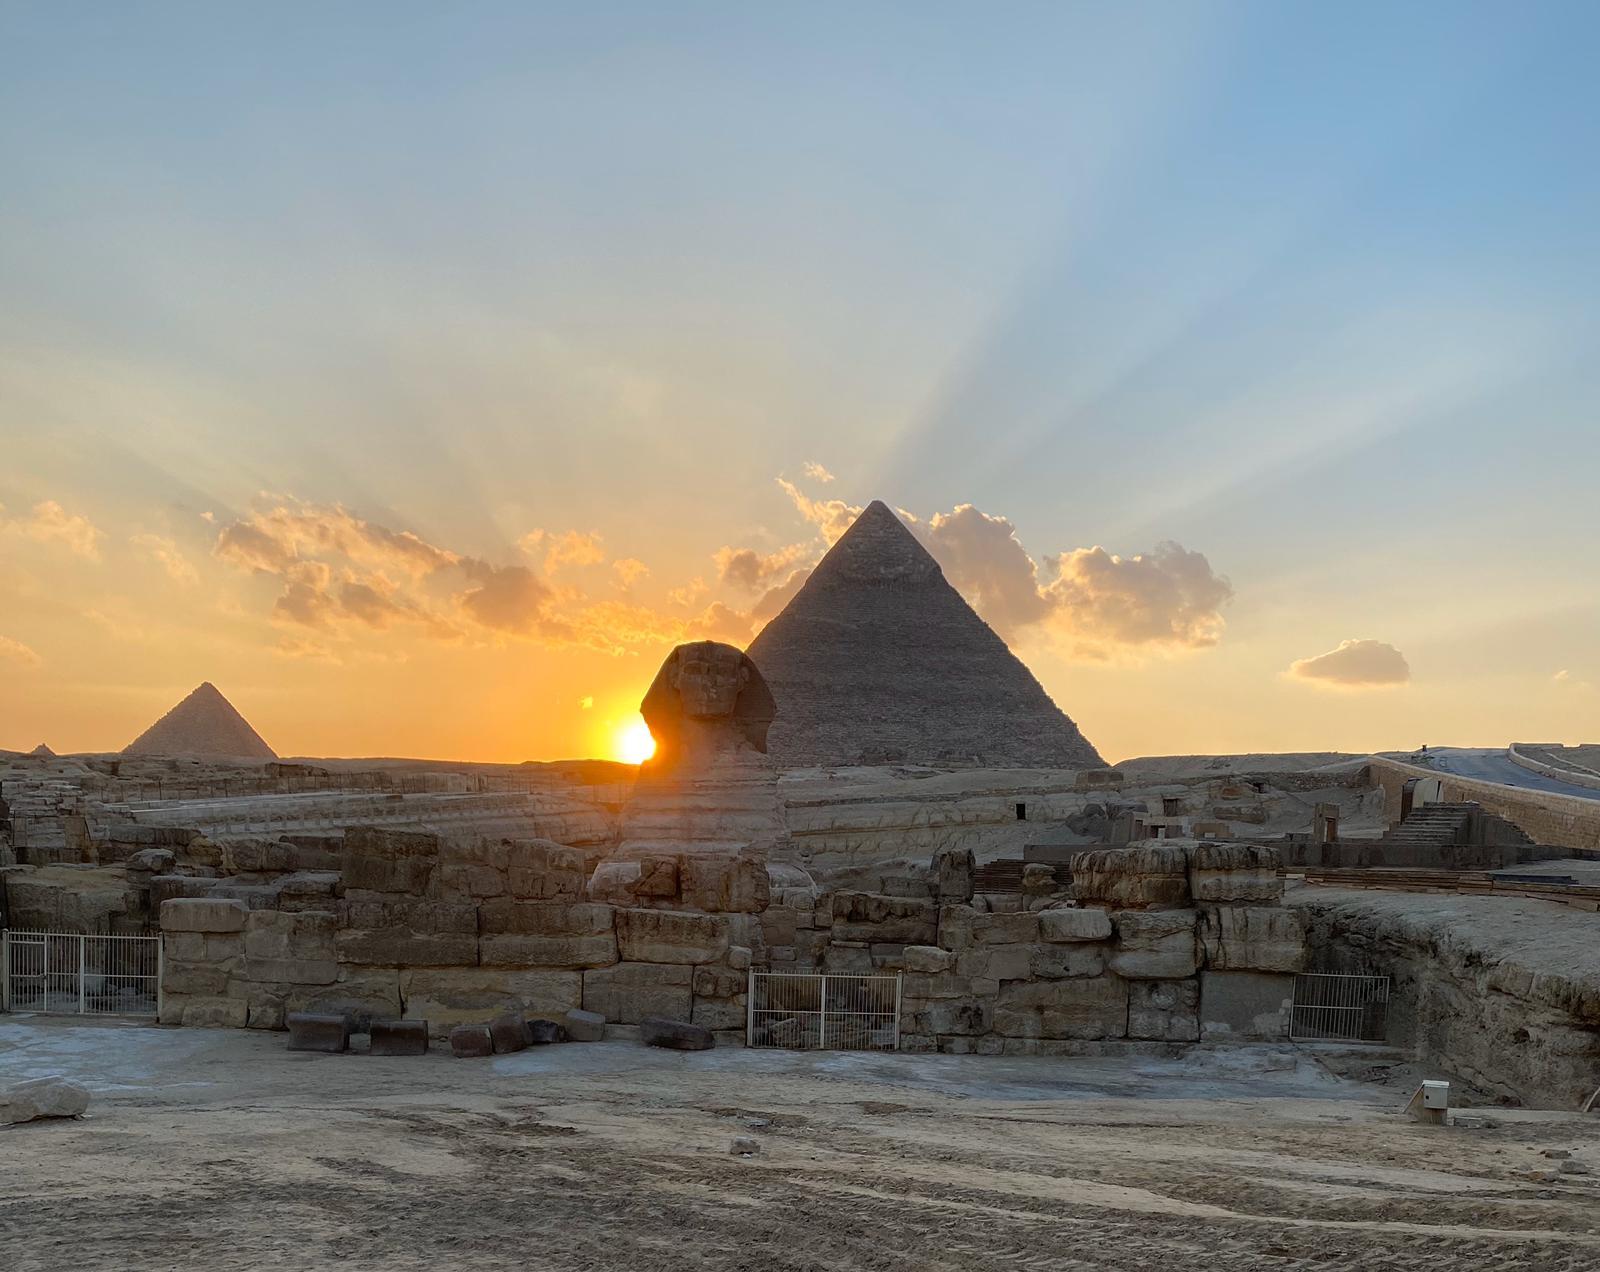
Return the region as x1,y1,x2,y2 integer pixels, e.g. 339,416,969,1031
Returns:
746,970,901,1051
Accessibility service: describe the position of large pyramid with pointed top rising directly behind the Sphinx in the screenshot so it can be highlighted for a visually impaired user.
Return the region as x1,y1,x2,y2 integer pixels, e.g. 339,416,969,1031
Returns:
749,501,1104,768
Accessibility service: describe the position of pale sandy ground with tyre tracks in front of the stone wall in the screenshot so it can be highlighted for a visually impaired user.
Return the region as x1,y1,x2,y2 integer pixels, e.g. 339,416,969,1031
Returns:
0,1018,1600,1272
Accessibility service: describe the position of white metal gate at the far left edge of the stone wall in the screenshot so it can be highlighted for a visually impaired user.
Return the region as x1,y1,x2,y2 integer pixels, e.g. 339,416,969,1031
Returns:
0,931,162,1016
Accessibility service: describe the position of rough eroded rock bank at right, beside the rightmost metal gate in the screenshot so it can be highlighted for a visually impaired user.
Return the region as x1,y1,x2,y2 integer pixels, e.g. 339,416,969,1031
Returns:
1291,886,1600,1109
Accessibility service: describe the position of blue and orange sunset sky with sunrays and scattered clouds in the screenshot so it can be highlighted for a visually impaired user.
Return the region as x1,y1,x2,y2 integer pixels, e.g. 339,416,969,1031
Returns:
0,0,1600,762
